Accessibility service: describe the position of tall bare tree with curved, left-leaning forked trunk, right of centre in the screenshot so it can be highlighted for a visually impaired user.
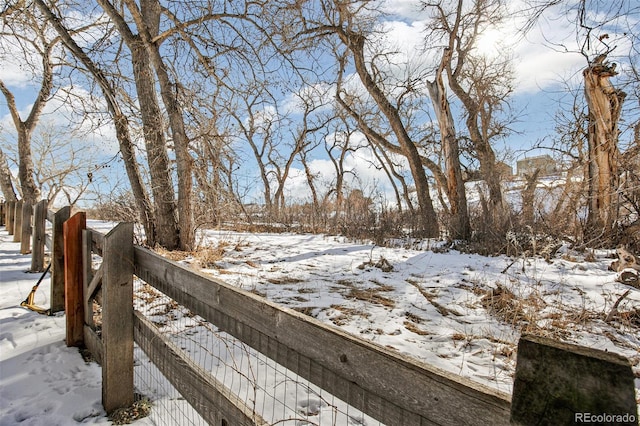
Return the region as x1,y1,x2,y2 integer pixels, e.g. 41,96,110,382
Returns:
300,5,439,237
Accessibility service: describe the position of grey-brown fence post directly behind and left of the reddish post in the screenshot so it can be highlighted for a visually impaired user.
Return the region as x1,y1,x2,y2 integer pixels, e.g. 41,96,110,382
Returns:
51,206,71,314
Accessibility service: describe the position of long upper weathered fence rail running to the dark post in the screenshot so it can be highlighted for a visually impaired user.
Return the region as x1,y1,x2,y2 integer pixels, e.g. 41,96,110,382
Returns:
135,247,510,425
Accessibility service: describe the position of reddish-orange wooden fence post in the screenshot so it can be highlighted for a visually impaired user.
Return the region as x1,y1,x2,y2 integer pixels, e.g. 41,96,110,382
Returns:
63,212,87,346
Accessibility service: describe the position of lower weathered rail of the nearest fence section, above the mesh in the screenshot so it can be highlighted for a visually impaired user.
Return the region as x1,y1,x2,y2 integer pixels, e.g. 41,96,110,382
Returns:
134,312,268,426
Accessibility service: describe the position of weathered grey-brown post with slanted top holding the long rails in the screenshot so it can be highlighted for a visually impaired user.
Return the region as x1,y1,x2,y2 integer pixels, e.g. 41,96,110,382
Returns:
102,223,134,413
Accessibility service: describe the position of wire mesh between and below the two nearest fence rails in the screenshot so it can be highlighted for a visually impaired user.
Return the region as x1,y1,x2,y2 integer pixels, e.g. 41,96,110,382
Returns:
134,282,381,426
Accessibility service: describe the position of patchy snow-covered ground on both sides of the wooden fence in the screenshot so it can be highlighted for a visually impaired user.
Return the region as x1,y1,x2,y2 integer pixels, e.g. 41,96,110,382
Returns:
0,224,640,426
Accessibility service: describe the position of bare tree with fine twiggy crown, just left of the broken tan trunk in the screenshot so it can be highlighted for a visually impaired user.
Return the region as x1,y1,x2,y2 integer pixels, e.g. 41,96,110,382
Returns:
423,0,513,231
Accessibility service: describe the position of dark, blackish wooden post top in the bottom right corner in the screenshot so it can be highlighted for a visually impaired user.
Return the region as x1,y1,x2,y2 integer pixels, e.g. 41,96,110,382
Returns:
511,336,638,426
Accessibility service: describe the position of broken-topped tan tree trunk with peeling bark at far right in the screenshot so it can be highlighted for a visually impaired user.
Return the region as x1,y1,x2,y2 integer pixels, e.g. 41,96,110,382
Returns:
582,55,626,238
